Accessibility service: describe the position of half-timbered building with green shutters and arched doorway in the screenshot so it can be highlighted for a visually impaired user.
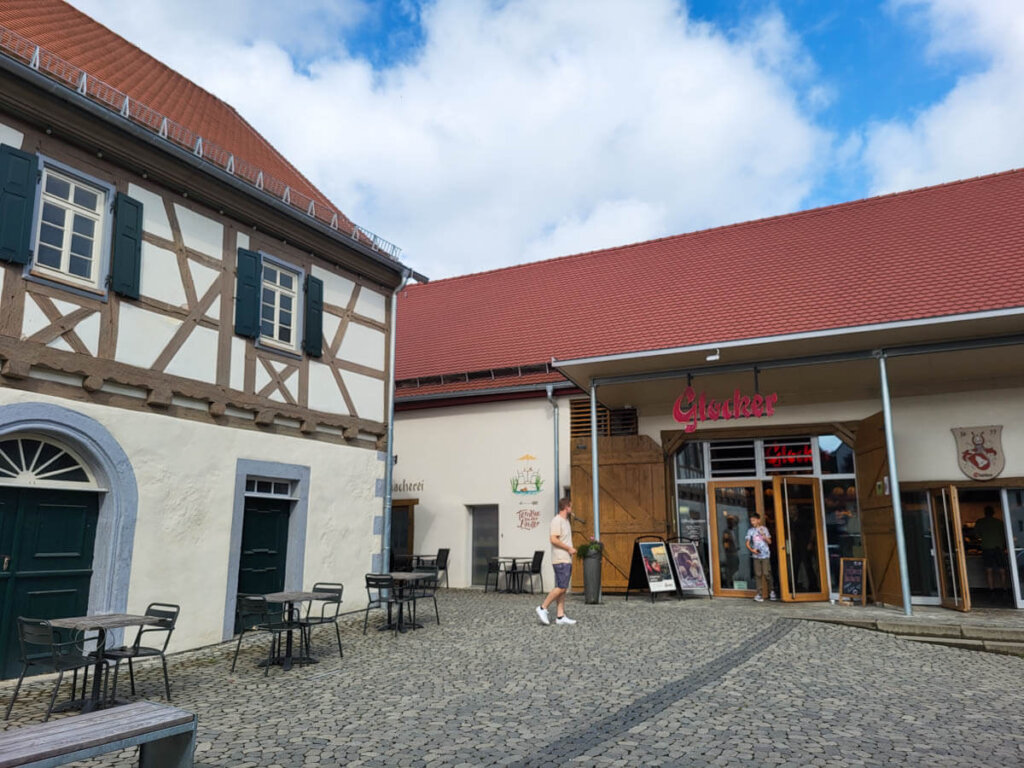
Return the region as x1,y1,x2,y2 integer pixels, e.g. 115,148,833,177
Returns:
0,0,417,676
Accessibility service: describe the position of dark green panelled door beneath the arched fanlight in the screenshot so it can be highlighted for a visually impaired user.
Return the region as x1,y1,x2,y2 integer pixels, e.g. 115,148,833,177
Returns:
0,487,99,678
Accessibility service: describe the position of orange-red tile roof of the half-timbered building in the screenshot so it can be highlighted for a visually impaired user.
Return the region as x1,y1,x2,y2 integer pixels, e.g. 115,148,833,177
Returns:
0,0,352,232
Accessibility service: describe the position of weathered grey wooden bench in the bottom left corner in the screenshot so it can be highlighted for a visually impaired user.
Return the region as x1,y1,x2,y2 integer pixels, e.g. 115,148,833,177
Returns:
0,701,197,768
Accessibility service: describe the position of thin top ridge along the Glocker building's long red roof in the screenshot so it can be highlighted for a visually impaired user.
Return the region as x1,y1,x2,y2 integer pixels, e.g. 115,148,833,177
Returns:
409,167,1024,289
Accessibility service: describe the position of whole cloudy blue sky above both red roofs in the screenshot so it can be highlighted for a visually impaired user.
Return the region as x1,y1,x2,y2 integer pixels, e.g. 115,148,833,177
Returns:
72,0,1024,279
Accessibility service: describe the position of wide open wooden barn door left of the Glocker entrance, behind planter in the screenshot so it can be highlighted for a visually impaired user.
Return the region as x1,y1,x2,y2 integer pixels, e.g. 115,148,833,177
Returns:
572,435,669,592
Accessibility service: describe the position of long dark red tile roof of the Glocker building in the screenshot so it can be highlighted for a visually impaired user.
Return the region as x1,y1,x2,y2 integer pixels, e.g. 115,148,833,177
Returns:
395,170,1024,380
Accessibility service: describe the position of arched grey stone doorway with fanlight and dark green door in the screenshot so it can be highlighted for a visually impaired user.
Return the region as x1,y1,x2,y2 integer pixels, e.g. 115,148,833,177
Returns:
0,402,138,677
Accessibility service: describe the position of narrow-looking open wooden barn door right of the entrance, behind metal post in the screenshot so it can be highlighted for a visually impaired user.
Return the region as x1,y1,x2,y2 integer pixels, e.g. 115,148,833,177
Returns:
854,411,903,607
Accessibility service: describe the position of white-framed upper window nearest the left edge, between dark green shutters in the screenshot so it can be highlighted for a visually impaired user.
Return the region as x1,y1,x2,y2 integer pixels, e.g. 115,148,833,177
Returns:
31,163,112,291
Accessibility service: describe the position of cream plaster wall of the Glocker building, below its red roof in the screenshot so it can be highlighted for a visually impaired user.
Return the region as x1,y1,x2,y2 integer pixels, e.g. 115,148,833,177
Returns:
394,389,1024,587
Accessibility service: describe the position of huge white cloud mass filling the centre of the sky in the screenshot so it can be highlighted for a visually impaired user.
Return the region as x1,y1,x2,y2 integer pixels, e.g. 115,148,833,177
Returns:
68,0,830,278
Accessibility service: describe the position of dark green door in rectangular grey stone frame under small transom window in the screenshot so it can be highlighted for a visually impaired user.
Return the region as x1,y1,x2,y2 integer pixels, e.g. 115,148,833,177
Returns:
239,498,292,595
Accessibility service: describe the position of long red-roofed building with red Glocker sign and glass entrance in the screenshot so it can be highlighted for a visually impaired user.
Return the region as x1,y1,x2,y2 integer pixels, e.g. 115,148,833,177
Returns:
392,170,1024,610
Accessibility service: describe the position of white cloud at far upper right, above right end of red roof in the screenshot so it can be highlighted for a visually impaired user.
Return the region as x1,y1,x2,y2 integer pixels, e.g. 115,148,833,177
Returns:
863,0,1024,193
